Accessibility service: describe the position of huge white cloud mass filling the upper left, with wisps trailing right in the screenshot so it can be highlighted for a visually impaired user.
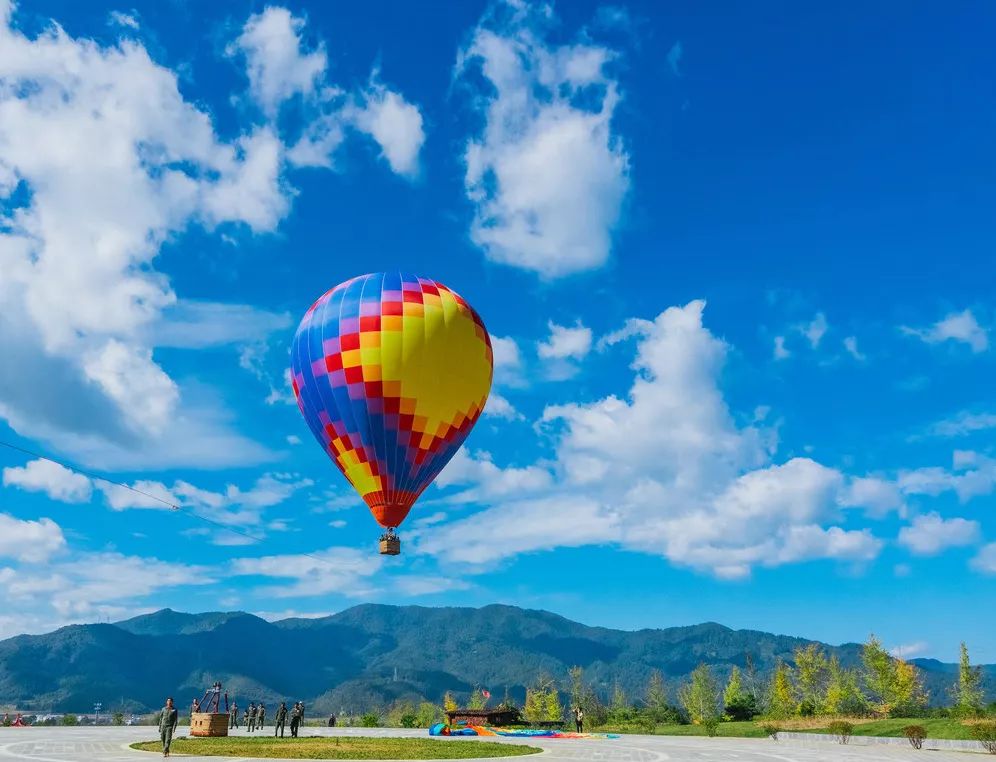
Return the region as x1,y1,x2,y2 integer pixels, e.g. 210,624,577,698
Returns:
0,4,420,468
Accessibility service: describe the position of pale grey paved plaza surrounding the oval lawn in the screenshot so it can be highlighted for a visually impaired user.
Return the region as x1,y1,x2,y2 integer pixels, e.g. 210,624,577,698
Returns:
0,727,988,762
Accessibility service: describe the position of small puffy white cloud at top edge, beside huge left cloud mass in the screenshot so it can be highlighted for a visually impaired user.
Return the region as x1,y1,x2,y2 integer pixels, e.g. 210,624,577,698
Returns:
229,6,328,118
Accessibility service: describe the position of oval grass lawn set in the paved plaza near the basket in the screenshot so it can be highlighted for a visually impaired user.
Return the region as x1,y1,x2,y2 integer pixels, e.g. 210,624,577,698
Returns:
131,737,541,759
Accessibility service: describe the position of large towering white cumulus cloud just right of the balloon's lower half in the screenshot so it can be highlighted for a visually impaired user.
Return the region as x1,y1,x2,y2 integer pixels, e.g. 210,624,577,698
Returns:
416,302,888,579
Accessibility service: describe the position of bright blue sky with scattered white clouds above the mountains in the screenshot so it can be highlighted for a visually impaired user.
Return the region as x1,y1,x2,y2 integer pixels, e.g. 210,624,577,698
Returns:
0,0,996,662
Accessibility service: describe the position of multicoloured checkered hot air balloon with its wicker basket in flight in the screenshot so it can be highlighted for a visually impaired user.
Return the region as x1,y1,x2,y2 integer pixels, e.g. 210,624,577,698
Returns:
291,273,494,555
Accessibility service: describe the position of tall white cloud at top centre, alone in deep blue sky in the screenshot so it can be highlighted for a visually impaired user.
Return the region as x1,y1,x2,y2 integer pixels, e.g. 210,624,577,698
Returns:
456,3,629,278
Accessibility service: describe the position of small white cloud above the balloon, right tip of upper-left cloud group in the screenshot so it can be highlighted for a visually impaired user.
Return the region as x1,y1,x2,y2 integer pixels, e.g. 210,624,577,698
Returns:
346,77,425,177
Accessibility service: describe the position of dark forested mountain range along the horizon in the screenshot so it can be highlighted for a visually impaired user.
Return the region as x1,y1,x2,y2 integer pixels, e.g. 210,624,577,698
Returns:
0,604,996,716
